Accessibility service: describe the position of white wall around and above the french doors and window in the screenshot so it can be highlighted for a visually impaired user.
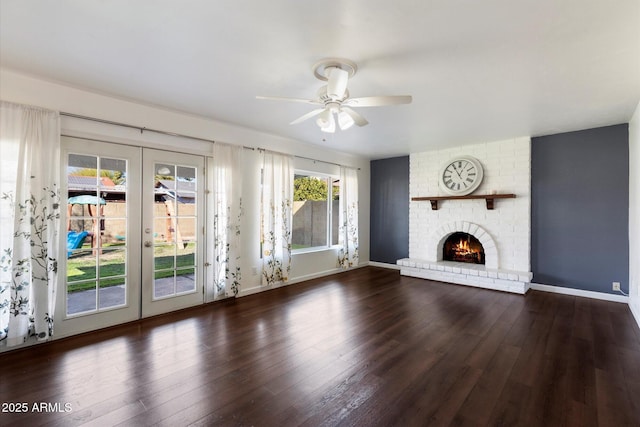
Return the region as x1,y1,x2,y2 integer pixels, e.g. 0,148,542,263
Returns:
0,68,370,300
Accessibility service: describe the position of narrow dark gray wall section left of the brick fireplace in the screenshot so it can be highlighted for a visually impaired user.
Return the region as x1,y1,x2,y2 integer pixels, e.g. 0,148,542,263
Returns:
369,156,409,264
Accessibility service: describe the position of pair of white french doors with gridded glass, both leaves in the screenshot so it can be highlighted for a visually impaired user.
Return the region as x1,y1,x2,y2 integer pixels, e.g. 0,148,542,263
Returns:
55,137,205,337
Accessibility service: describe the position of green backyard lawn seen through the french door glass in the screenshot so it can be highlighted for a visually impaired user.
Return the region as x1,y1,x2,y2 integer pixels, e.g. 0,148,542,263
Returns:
67,243,195,292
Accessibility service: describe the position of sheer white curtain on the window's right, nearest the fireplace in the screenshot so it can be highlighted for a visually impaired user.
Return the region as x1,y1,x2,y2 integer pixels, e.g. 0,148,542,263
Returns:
338,166,359,268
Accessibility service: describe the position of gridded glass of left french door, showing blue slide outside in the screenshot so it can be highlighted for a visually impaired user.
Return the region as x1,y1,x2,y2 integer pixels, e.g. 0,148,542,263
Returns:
66,154,127,315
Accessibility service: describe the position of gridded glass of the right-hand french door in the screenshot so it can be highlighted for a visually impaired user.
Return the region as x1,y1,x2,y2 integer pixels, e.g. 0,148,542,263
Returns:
153,163,197,299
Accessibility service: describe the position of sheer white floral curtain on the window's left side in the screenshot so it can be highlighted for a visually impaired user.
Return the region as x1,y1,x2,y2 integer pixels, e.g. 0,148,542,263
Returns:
261,152,293,285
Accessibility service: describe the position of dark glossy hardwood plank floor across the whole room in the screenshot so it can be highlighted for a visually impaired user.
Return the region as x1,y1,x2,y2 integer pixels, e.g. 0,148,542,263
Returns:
0,267,640,427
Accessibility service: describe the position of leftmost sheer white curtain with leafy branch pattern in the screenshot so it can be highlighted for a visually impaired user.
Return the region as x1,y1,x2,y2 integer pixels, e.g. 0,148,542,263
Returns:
0,101,60,346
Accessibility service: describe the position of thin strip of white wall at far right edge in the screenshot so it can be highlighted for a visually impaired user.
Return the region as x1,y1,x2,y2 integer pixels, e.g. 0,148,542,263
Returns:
629,103,640,326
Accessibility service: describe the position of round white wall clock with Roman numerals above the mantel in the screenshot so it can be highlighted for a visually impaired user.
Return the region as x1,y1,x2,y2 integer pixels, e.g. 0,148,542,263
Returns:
439,156,483,196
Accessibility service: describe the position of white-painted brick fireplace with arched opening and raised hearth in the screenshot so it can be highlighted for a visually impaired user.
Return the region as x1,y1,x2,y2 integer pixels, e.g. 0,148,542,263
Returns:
398,137,532,294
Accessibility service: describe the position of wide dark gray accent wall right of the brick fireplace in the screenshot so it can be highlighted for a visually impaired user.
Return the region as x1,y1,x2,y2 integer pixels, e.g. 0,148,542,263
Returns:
531,124,629,293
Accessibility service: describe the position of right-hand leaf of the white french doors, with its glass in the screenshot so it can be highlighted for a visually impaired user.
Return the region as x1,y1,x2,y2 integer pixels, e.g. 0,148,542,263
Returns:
142,149,205,317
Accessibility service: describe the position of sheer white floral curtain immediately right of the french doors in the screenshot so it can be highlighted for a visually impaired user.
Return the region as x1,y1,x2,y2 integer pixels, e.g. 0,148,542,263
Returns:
209,143,242,299
